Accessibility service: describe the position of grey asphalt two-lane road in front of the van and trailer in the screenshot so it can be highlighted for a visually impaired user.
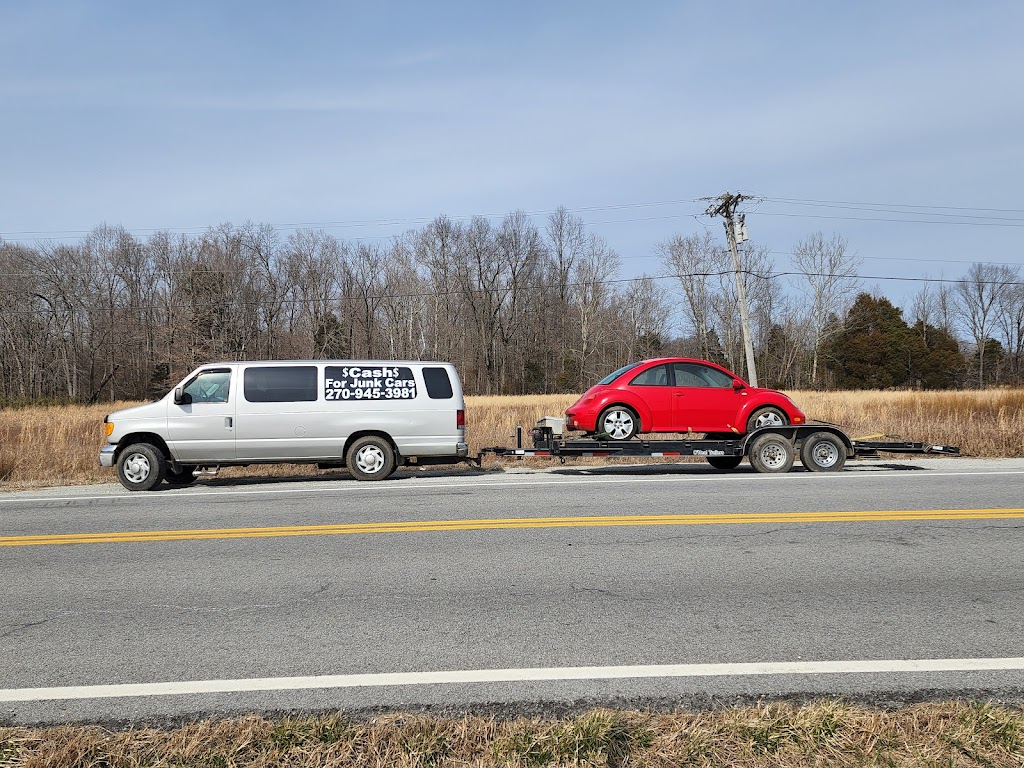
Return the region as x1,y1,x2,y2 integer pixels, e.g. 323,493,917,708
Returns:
0,459,1024,722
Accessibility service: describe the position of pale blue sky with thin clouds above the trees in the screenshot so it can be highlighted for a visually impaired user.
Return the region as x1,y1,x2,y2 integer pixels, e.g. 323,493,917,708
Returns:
0,0,1024,307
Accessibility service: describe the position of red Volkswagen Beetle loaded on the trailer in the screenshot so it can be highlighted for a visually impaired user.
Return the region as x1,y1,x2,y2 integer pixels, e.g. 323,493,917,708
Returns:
565,357,806,440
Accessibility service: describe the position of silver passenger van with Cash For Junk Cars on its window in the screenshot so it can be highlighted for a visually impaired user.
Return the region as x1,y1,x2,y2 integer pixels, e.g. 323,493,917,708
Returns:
99,360,469,490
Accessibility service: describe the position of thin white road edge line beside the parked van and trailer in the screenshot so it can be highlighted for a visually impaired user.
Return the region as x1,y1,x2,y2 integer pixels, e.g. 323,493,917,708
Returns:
6,467,1024,504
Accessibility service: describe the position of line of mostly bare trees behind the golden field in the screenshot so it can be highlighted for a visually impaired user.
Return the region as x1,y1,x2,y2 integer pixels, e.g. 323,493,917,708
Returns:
0,209,1024,404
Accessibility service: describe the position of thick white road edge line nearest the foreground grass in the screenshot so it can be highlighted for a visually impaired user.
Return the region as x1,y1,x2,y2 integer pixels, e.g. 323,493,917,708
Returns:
0,657,1024,702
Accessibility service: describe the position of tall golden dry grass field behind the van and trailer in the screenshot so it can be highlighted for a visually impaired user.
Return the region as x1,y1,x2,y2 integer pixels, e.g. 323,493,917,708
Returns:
0,389,1024,488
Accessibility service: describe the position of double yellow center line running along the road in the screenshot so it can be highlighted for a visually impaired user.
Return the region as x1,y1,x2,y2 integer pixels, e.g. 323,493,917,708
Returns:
0,509,1024,547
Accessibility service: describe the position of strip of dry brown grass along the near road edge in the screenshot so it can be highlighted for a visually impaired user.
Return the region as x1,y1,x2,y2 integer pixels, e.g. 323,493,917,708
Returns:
0,700,1024,768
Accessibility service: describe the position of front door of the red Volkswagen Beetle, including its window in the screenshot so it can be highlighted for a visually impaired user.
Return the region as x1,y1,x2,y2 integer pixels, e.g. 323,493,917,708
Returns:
672,362,746,432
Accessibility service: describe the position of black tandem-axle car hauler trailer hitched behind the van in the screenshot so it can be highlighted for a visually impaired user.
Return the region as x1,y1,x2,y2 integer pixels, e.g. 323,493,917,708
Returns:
474,416,959,473
